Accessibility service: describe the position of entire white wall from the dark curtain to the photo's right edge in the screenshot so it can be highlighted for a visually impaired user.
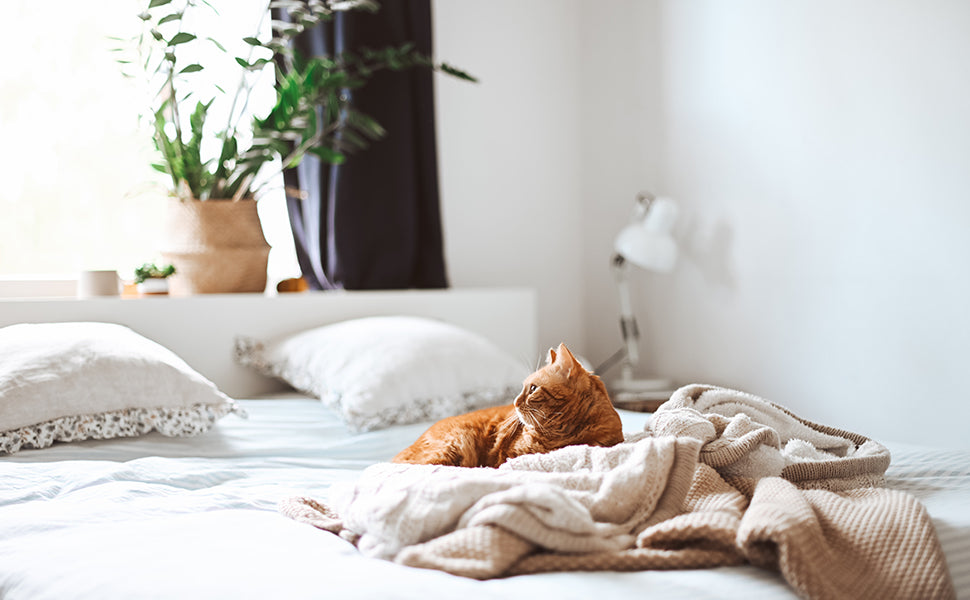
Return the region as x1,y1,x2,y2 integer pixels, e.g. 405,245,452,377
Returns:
435,0,970,447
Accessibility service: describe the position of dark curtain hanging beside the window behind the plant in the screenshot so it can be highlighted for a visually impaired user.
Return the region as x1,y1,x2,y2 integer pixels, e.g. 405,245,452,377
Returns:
284,0,448,289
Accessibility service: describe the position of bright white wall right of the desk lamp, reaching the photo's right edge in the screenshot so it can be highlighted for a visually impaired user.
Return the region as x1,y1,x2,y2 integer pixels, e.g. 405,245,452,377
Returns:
646,0,970,446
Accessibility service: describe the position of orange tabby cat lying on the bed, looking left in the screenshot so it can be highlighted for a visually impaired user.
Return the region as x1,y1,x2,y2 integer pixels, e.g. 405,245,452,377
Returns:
392,344,623,467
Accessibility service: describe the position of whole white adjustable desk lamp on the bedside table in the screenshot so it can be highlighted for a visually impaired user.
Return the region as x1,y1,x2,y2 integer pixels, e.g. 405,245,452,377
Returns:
596,192,677,402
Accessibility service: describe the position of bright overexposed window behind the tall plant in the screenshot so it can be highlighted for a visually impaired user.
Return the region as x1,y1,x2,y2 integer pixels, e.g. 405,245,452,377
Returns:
0,0,299,282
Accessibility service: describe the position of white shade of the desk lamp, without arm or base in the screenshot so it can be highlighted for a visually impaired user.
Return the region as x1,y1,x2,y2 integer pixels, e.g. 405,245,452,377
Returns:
613,197,677,273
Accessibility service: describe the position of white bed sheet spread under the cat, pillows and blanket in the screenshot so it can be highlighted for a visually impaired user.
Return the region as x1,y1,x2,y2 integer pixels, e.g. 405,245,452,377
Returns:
0,395,970,600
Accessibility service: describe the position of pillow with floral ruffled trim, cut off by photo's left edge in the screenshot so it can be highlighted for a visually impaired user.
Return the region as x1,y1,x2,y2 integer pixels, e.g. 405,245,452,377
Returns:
0,323,239,453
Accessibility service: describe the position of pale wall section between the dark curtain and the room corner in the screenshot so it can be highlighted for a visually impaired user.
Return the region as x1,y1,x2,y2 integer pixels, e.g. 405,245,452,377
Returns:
432,0,585,356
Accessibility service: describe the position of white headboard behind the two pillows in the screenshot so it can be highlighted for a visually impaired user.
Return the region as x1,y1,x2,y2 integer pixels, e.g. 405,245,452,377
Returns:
0,288,538,398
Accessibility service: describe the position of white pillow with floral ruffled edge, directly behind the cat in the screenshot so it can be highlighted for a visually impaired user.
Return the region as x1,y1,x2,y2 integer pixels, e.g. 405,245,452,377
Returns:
236,316,528,431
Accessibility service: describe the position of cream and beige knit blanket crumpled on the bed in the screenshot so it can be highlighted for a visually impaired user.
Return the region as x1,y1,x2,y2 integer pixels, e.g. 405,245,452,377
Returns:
280,385,954,599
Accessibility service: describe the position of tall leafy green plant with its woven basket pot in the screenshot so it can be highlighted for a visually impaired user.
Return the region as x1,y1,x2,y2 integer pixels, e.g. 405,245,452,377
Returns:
119,0,474,293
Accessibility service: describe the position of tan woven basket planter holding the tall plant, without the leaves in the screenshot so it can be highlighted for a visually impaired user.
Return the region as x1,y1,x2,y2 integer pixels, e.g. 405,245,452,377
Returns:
161,198,270,295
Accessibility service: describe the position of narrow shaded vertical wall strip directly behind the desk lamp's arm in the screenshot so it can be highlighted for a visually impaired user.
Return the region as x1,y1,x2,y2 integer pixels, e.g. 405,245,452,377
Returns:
578,0,662,376
